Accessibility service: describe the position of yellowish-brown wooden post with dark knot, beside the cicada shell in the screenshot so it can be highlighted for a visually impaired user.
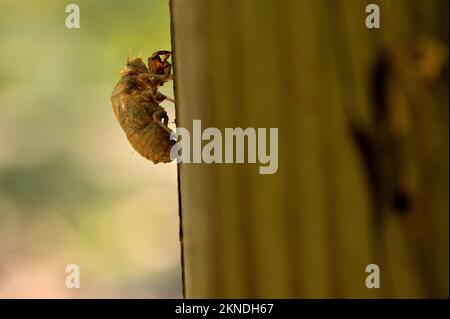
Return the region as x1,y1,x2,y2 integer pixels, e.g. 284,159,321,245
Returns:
171,0,449,298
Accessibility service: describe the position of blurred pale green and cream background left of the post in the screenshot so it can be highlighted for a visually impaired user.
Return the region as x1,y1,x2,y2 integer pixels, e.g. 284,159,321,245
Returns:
0,0,181,298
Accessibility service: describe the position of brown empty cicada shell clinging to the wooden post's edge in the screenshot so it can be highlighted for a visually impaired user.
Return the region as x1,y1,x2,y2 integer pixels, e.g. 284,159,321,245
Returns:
111,51,176,164
